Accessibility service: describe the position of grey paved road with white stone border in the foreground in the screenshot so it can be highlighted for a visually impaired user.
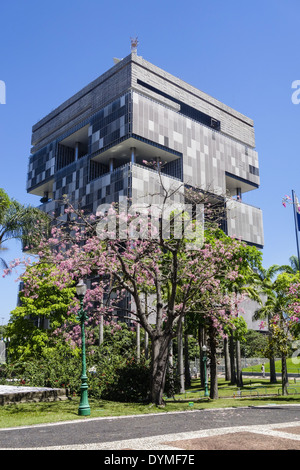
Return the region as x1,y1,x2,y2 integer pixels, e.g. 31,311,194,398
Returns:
0,405,300,450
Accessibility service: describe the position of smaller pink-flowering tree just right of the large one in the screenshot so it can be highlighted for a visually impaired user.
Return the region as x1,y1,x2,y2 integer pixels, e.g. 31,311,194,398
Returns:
187,230,261,399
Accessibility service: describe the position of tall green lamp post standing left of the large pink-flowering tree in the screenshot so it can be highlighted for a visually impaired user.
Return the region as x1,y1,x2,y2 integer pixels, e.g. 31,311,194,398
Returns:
76,280,91,416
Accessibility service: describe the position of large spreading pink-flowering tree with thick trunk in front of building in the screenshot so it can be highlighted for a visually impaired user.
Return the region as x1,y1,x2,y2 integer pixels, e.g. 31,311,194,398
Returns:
4,192,250,405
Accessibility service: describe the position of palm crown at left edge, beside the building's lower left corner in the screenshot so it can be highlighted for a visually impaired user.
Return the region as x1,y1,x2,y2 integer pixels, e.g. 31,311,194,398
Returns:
0,188,49,268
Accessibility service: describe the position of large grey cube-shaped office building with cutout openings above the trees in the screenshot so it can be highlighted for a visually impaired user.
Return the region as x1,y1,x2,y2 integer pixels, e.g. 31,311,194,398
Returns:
27,51,264,247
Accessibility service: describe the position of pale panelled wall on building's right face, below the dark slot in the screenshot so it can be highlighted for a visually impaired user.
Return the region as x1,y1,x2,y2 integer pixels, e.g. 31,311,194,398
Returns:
132,93,259,195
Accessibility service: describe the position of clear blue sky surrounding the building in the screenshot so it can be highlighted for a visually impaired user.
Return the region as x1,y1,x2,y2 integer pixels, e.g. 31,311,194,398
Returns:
0,0,300,324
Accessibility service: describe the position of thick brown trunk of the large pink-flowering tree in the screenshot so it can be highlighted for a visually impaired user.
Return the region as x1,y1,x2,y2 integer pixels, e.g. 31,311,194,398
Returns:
150,335,171,405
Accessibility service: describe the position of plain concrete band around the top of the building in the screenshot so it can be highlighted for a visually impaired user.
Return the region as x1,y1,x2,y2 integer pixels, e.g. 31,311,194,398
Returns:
32,54,255,152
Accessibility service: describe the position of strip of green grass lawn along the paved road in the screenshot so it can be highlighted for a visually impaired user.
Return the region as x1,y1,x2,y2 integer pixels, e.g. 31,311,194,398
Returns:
0,378,300,428
